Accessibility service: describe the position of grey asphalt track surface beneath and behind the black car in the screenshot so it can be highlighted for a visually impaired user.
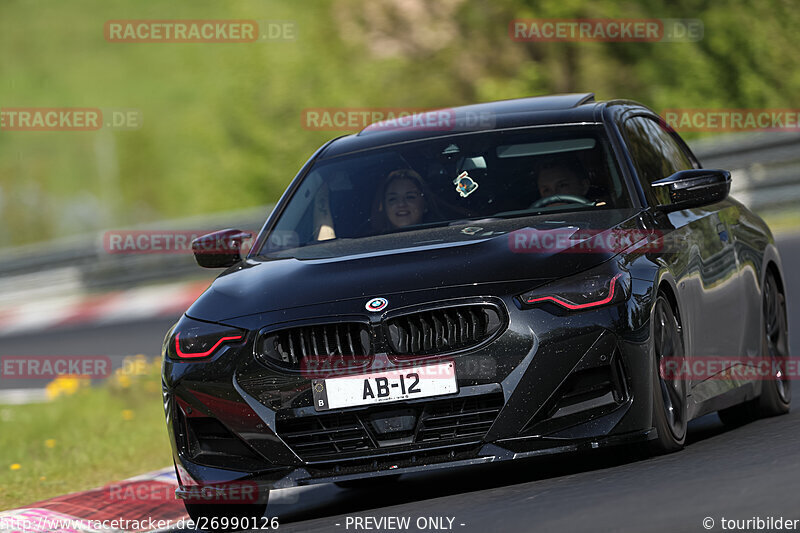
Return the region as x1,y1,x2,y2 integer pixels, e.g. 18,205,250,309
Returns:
10,235,800,533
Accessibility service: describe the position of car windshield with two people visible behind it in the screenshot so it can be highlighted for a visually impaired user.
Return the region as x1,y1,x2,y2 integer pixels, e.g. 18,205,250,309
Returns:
259,126,631,258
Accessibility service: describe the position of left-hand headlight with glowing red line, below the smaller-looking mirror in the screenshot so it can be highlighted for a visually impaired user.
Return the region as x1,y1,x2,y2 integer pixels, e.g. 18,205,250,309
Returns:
165,317,245,360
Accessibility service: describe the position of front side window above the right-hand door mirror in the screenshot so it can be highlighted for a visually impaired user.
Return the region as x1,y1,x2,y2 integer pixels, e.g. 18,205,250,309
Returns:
623,117,693,201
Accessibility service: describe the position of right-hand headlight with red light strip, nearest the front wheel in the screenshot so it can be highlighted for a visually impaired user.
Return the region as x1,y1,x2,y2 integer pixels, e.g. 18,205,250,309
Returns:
519,261,631,311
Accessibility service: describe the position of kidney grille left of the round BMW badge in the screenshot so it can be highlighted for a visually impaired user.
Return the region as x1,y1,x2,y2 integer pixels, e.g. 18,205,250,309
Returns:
259,322,372,370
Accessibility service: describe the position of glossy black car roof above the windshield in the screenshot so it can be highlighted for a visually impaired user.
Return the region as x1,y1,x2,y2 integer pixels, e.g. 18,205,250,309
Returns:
319,93,608,159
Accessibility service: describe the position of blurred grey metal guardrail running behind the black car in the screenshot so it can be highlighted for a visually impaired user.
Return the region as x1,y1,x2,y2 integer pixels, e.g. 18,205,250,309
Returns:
0,132,800,296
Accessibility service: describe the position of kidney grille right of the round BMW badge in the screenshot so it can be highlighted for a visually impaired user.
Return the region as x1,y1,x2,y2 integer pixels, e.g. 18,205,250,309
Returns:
386,305,503,356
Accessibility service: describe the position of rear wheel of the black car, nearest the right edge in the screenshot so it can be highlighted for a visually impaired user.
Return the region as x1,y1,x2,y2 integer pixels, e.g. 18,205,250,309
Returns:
718,272,792,427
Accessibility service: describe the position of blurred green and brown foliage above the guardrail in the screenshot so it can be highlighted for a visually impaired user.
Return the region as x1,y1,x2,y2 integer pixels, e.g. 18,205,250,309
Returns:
0,0,800,246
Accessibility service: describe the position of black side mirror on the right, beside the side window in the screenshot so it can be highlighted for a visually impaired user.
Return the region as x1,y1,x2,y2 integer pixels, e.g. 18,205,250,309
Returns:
650,168,731,212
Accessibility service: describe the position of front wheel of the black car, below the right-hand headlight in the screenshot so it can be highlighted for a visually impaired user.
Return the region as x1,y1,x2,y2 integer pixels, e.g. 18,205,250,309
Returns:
648,293,688,455
